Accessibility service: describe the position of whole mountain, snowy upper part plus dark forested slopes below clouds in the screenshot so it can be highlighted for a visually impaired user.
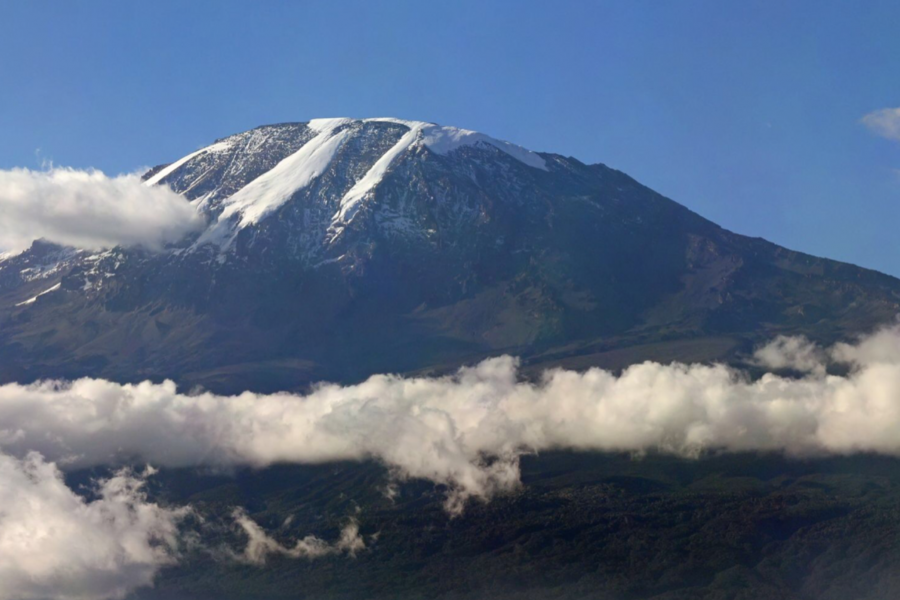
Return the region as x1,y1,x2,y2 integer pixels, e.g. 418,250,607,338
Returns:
8,119,900,600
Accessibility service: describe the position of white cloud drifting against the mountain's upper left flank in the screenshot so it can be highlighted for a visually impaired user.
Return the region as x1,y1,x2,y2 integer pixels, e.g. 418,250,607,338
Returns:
0,168,204,251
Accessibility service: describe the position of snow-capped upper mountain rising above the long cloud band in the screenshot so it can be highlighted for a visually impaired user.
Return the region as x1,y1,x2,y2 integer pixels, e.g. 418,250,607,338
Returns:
0,119,900,392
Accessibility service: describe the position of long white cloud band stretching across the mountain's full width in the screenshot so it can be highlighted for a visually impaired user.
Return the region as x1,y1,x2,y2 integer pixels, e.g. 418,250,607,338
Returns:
0,328,900,511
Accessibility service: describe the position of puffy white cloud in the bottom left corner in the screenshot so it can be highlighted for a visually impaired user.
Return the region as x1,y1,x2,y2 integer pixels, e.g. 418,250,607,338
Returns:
0,453,186,600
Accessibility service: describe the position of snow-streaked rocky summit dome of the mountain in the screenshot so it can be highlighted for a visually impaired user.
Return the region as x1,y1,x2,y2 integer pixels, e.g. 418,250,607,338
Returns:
146,117,548,255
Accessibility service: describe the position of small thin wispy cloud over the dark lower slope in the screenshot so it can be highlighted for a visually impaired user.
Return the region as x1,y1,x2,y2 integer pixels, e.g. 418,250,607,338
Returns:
232,509,366,566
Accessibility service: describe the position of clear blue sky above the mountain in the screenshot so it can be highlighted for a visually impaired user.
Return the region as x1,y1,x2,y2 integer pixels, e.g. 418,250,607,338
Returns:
0,0,900,275
